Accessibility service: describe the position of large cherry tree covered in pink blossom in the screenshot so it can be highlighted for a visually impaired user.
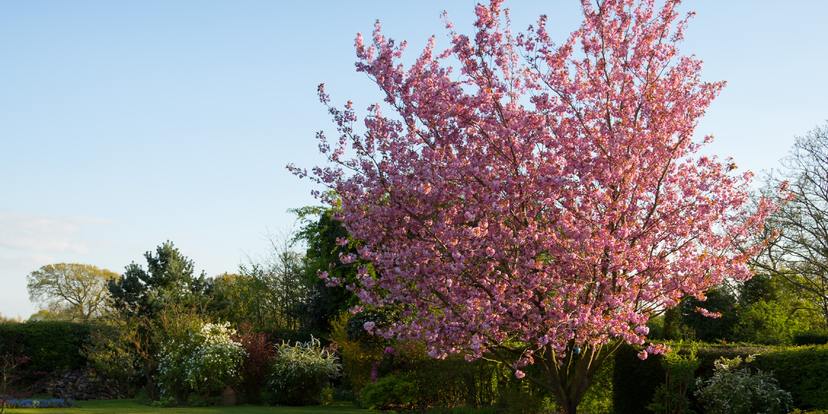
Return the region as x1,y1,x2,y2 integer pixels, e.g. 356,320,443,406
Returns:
290,0,773,413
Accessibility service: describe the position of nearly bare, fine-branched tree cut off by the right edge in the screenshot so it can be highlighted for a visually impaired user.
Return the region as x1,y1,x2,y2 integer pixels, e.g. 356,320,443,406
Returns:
753,124,828,327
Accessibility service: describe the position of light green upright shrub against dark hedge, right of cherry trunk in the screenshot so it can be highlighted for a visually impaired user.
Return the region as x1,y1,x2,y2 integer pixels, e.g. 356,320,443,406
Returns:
647,346,700,414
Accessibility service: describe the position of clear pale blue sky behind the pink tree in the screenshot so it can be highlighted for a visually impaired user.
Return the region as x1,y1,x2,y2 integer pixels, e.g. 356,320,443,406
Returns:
0,0,828,317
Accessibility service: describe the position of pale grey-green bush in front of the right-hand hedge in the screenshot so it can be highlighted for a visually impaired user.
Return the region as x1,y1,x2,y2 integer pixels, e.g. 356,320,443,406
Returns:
696,357,793,414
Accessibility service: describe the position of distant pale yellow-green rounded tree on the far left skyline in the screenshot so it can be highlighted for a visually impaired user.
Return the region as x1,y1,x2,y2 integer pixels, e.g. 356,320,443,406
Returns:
27,263,118,321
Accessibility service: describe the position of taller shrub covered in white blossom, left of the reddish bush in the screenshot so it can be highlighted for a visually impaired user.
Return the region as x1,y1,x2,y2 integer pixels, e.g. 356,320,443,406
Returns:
158,323,246,400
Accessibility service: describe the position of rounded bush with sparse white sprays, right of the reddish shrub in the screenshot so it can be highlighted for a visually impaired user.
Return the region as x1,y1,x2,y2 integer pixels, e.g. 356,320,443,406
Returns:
268,338,342,405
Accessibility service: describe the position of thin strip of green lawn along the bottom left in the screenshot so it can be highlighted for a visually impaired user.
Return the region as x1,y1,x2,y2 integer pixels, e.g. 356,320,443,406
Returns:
6,400,368,414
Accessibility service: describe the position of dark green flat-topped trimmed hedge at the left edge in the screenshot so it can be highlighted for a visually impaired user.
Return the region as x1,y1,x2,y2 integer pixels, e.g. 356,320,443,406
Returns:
0,321,92,376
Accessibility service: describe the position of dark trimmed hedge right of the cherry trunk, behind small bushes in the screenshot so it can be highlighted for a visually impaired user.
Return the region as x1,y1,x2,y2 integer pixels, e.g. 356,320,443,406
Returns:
613,344,828,414
